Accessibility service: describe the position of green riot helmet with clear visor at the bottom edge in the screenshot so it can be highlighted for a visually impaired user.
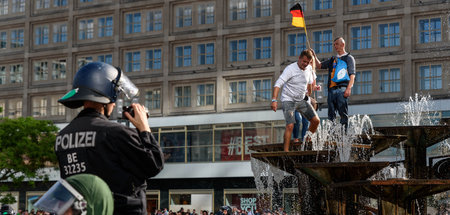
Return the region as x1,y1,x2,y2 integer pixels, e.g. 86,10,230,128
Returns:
34,174,114,215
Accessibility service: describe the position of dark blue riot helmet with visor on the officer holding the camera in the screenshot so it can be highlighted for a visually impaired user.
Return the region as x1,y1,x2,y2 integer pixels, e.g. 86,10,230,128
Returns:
58,62,139,109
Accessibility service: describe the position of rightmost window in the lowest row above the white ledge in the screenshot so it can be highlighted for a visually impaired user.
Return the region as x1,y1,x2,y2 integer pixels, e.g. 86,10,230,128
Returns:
419,65,442,90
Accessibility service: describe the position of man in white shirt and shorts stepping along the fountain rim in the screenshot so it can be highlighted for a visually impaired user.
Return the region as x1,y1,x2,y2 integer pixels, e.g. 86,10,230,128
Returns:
270,50,320,152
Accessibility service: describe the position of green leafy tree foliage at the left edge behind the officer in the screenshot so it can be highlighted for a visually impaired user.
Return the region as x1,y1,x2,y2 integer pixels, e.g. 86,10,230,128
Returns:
0,117,58,203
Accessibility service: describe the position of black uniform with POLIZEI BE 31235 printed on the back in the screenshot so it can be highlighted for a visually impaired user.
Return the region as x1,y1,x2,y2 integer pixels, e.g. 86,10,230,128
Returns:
55,109,164,214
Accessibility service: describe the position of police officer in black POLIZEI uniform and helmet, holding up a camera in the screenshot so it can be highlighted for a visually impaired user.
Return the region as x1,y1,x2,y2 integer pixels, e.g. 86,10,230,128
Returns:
55,62,164,214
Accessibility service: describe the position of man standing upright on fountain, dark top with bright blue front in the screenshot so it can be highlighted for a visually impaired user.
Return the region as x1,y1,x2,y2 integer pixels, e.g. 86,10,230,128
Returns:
312,37,355,128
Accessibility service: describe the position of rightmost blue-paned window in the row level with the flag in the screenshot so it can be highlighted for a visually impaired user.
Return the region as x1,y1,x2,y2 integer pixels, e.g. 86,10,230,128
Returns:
419,18,441,43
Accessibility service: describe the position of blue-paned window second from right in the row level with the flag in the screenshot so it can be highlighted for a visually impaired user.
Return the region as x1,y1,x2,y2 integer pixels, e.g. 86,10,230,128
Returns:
378,22,400,48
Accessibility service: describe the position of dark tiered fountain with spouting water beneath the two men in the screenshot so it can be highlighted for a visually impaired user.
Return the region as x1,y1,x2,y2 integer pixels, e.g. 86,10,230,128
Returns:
250,95,450,214
